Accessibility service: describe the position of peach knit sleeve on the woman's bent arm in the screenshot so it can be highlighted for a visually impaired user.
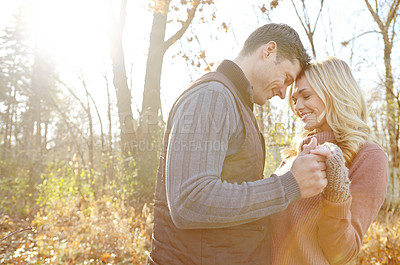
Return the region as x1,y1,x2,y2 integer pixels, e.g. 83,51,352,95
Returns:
318,144,388,264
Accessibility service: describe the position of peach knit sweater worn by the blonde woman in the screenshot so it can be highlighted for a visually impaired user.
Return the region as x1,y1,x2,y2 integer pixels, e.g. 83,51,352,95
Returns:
270,132,388,265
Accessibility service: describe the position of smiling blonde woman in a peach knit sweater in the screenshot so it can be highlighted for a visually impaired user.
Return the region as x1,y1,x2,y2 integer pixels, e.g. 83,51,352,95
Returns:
270,57,387,265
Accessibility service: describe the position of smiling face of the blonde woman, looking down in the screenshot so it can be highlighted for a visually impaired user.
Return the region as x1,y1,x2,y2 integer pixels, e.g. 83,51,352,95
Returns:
292,75,331,131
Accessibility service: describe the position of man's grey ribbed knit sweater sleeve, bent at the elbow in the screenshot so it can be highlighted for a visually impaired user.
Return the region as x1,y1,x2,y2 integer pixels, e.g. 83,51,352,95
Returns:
166,82,300,229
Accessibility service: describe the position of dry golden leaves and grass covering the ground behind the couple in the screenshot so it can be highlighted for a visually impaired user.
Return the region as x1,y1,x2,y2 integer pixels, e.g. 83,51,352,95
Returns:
0,201,400,265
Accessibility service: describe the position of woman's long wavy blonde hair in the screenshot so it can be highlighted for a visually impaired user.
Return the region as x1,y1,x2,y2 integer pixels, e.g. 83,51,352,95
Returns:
283,56,371,165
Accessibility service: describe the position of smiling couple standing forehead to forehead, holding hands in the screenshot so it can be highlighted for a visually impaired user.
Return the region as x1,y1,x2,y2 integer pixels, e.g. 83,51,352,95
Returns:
148,24,387,265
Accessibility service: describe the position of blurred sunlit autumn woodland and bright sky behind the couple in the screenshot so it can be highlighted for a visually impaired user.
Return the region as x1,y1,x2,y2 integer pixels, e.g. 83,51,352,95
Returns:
0,0,400,264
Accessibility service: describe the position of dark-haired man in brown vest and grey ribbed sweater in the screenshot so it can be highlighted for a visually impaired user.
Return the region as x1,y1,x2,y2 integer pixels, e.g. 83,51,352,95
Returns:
148,24,326,265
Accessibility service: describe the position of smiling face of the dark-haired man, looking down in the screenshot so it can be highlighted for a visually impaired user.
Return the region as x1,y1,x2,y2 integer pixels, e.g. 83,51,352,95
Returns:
250,52,301,105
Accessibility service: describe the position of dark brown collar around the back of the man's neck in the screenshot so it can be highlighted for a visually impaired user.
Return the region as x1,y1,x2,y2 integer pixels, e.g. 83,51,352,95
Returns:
216,60,254,110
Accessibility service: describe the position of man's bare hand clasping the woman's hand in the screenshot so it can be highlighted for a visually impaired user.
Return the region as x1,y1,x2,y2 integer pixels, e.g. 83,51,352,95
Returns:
290,138,331,199
